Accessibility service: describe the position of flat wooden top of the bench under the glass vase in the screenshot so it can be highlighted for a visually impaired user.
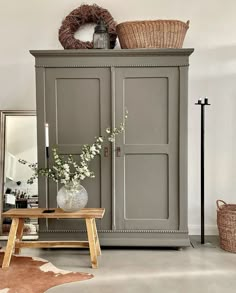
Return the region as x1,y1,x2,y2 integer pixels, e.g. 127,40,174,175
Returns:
2,208,105,219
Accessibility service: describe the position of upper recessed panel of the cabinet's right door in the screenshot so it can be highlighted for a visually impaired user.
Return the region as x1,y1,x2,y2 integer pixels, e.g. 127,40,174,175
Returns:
124,77,168,145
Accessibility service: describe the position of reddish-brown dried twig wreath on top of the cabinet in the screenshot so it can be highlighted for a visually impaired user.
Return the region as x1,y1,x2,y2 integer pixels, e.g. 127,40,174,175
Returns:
59,4,117,49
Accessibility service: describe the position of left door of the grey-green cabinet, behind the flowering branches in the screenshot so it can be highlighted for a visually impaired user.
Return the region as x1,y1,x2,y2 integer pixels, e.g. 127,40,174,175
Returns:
45,68,111,230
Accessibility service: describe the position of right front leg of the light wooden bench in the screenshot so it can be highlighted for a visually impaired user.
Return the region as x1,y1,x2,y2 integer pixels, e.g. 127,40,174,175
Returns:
85,219,98,269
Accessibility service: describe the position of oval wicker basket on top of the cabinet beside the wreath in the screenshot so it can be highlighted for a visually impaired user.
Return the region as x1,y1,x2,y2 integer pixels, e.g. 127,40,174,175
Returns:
116,20,189,49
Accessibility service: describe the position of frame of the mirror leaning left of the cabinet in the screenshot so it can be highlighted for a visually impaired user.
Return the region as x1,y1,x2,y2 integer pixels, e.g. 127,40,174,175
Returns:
0,110,36,236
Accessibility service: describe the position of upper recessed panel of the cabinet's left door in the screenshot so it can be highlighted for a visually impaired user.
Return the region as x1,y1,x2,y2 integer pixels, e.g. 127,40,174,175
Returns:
56,78,102,145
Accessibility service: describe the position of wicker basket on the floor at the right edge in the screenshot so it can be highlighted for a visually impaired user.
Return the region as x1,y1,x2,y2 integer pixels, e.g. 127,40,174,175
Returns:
216,200,236,252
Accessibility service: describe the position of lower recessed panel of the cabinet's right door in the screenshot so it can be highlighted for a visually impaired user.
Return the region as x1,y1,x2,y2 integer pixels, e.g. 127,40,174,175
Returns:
125,154,169,219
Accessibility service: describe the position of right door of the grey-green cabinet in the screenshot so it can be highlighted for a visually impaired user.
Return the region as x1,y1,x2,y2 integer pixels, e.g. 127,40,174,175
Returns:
113,68,179,230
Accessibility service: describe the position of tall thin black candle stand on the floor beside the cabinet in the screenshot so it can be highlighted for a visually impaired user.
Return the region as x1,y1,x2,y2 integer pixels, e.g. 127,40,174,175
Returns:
195,97,210,244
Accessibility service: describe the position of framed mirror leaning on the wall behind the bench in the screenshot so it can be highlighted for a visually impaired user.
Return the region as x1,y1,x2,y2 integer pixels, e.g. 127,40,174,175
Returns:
0,111,38,238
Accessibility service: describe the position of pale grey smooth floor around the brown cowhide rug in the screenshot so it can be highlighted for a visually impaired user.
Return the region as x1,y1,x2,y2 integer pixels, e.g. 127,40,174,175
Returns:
1,239,236,293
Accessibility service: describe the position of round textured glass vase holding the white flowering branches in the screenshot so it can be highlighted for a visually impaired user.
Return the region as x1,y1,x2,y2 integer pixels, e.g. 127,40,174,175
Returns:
57,183,88,213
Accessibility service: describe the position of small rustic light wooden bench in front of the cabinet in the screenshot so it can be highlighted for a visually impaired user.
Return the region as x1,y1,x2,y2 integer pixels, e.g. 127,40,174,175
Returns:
2,208,105,269
